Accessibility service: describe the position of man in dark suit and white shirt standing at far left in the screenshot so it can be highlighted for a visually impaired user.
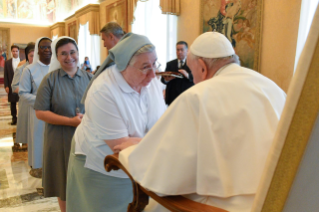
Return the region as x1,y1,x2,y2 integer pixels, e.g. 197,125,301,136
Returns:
4,45,20,125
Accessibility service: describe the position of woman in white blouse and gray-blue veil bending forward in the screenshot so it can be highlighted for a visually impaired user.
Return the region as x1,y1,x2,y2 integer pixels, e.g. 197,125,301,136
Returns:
67,33,166,212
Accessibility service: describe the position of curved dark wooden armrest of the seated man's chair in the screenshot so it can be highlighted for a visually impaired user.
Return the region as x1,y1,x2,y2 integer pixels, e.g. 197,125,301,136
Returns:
104,154,227,212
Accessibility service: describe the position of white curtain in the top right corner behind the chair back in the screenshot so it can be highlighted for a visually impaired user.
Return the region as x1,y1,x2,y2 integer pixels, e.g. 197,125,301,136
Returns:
295,0,319,70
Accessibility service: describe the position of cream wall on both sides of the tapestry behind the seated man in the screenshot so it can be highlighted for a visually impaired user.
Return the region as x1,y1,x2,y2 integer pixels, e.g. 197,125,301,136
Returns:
177,0,301,92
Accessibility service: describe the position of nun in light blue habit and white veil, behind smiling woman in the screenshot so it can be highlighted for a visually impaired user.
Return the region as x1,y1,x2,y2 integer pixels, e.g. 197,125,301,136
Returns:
19,37,52,178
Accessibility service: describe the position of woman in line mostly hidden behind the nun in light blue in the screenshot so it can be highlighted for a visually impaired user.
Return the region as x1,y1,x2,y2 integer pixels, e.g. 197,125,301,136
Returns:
11,42,35,149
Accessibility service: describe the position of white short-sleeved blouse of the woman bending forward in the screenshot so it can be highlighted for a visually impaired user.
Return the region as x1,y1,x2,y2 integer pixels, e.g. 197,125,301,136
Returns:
75,65,166,178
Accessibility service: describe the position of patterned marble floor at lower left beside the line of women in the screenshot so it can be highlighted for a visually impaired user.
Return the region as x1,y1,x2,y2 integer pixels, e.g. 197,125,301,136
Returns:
0,85,60,212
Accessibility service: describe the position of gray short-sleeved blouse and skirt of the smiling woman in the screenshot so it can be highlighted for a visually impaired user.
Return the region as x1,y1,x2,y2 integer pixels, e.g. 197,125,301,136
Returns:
34,69,92,200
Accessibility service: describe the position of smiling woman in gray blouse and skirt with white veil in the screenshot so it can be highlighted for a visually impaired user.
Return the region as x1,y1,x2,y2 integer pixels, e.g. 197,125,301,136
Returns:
34,36,93,212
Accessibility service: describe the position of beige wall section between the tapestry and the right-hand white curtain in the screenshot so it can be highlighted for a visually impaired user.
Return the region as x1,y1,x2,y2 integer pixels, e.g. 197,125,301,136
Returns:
261,0,301,92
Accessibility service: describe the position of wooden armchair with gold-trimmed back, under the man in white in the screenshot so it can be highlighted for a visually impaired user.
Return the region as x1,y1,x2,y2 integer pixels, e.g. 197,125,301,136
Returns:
105,8,319,212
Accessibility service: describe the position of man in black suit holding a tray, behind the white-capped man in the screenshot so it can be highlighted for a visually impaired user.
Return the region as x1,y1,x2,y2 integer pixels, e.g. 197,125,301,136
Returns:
161,41,194,105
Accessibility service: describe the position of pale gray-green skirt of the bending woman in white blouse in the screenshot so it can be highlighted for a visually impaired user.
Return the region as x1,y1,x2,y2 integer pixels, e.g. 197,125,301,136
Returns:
66,138,133,212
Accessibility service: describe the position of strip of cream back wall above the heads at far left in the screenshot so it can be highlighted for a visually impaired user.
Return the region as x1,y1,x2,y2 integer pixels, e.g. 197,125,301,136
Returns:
1,22,51,45
